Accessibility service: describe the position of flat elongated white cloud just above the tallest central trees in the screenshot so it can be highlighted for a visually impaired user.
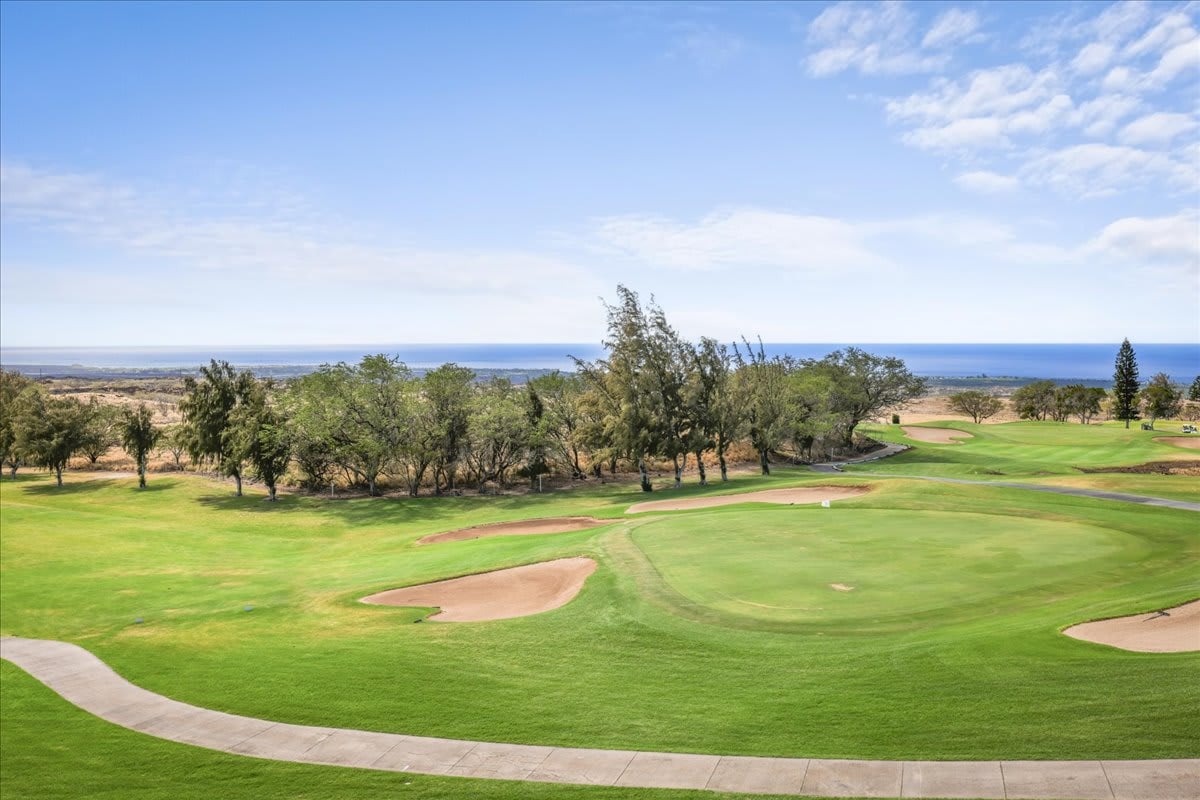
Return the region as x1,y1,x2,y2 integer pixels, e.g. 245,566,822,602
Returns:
593,209,888,272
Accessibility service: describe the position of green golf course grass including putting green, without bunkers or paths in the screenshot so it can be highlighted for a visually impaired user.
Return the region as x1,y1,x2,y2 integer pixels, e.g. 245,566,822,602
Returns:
0,422,1200,798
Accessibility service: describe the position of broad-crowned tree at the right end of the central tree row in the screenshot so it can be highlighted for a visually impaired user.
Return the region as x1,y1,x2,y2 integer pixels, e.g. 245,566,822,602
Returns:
822,347,925,447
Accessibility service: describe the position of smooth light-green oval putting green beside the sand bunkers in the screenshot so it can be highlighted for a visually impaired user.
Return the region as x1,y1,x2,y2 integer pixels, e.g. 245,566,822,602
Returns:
632,507,1141,634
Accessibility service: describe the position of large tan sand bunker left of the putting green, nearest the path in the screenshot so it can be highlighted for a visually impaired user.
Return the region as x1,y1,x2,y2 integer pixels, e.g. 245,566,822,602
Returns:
360,558,596,622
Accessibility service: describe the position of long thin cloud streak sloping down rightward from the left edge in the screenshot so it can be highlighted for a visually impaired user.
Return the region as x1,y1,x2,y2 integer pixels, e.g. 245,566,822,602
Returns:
0,162,593,296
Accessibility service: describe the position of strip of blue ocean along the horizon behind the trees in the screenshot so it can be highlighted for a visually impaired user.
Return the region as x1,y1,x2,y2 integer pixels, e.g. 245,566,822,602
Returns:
0,343,1200,383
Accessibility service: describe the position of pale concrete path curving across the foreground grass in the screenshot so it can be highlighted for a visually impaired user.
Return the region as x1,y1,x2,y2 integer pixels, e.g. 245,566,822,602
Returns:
0,637,1200,800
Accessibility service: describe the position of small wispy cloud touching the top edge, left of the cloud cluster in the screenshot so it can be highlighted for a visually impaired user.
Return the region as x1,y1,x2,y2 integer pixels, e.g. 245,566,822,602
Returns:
805,0,947,77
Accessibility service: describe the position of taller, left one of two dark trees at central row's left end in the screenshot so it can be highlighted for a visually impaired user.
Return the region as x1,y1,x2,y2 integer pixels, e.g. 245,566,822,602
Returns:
179,359,254,497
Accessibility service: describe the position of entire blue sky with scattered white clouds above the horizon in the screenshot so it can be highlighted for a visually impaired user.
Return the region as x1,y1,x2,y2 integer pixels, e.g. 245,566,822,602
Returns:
0,1,1200,347
